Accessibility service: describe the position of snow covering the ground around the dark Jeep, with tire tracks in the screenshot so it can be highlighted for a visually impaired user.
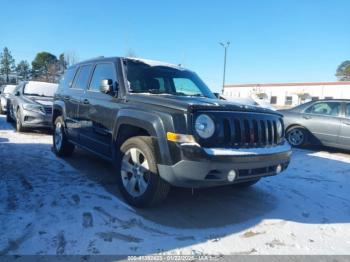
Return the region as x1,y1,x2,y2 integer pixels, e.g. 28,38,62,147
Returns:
0,116,350,255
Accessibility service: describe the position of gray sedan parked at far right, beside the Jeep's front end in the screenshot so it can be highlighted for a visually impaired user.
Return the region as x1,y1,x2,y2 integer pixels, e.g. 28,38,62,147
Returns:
279,100,350,150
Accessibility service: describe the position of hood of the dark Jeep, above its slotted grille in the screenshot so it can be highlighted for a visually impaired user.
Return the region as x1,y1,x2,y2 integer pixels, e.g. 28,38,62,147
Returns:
127,94,280,115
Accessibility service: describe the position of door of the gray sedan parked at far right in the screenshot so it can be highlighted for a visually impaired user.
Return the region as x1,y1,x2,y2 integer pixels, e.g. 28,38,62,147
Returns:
302,101,342,145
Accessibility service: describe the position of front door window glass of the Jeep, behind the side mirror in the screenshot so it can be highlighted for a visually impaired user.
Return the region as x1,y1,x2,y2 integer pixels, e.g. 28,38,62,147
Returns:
89,63,117,91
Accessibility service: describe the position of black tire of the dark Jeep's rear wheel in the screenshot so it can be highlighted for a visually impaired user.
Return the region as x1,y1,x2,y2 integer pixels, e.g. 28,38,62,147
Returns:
52,116,75,157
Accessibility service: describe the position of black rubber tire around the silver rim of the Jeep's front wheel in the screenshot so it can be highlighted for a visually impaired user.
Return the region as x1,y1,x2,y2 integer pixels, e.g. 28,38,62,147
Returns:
116,136,170,207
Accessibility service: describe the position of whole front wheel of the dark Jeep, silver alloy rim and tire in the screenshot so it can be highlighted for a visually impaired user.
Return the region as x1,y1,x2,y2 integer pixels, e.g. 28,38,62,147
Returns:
117,136,170,207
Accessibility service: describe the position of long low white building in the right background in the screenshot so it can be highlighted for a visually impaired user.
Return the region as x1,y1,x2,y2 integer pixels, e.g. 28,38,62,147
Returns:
223,81,350,107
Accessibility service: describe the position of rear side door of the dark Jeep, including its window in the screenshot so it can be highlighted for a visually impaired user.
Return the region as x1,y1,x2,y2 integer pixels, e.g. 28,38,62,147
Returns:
63,65,92,142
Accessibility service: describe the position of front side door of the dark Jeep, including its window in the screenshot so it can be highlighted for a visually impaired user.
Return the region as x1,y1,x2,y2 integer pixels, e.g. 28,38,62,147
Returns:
79,62,120,157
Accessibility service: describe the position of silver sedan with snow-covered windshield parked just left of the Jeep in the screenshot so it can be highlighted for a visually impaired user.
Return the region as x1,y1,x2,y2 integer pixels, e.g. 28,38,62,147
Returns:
7,81,58,132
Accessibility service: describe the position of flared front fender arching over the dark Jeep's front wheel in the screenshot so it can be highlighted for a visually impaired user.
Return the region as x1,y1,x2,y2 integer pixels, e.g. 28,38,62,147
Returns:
113,109,171,164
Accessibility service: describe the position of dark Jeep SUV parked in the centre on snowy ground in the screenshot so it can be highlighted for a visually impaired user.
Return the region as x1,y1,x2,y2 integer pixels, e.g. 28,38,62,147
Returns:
53,58,291,206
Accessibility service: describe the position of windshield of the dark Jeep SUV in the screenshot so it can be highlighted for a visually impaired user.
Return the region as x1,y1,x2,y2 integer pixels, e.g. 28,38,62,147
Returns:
127,60,216,99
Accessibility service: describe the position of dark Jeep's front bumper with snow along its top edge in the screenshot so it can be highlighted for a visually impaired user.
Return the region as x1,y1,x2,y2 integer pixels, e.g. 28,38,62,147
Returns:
158,142,292,188
